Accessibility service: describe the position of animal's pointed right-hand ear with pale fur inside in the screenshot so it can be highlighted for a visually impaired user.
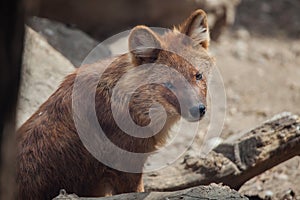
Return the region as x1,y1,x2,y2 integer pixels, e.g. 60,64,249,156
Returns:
179,9,210,49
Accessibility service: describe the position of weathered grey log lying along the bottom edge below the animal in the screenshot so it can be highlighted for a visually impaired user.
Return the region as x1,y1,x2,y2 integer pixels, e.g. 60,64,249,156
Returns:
54,184,248,200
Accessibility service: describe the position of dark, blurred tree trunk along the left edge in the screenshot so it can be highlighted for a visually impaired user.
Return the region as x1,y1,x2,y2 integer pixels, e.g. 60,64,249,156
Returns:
0,0,24,200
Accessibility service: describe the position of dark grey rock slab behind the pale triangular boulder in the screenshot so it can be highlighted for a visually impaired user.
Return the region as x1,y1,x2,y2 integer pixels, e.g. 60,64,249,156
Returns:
28,17,111,67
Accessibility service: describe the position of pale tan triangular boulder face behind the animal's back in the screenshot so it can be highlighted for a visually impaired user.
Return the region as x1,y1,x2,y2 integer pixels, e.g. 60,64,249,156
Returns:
17,27,74,127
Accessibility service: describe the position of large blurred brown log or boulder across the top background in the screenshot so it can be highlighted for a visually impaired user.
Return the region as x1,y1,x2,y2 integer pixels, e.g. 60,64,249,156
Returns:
28,0,240,40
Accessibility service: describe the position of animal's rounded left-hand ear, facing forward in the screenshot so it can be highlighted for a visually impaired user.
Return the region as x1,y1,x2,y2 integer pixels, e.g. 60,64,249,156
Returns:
128,26,161,64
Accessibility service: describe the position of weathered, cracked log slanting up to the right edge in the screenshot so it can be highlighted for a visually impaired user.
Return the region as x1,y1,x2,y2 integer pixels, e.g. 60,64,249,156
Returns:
144,113,300,191
